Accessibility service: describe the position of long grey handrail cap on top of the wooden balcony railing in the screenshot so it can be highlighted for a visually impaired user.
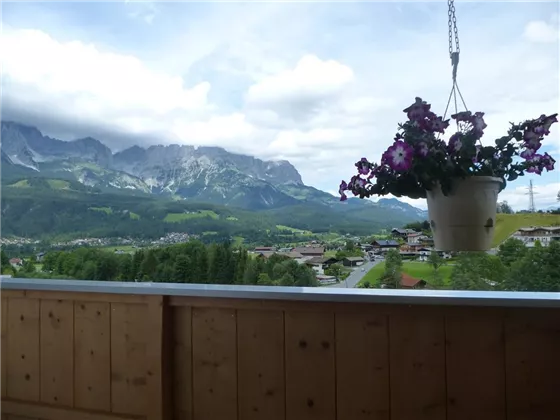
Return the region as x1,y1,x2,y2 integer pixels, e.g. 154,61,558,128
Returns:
0,278,560,308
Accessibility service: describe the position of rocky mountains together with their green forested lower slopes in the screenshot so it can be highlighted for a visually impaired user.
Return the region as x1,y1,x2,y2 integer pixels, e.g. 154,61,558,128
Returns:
0,121,426,243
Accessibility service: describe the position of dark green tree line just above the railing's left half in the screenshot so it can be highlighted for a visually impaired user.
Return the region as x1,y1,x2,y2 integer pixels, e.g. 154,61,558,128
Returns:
14,241,318,287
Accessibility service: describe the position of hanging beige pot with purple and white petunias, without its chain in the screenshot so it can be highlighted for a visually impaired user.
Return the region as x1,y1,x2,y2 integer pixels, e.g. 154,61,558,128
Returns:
339,98,558,251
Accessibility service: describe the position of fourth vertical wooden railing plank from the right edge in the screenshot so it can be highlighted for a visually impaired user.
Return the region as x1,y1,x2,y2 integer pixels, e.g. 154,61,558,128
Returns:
336,313,390,420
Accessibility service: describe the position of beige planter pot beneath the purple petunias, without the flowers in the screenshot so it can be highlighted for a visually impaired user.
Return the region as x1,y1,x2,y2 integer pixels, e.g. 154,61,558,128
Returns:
427,176,502,251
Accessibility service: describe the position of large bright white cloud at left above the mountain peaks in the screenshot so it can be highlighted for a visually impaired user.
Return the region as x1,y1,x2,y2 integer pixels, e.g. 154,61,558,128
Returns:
0,28,210,131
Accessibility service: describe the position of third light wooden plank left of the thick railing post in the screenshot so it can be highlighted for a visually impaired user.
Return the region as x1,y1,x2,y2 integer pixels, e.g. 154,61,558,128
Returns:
40,300,74,407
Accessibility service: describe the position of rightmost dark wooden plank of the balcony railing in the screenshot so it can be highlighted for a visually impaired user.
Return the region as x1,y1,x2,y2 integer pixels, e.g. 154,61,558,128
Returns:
505,308,560,420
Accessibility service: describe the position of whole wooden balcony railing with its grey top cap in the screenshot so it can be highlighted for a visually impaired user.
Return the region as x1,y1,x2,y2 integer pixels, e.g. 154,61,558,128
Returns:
0,279,560,420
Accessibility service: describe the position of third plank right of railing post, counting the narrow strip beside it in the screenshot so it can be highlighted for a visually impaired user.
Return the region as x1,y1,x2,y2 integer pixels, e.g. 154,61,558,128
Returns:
237,310,286,420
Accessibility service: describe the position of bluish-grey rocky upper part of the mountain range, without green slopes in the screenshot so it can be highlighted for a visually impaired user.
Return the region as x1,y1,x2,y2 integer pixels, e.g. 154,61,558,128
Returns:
0,121,426,222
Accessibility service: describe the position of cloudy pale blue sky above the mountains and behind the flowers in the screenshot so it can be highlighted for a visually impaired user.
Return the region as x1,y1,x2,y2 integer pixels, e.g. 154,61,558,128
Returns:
0,0,560,210
